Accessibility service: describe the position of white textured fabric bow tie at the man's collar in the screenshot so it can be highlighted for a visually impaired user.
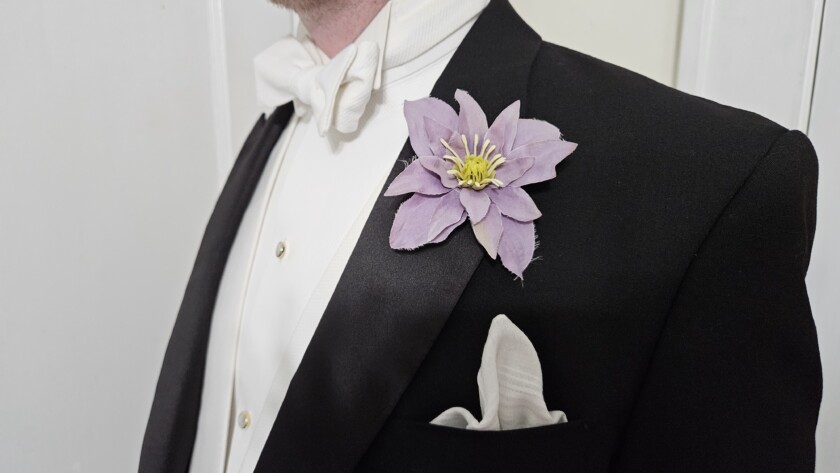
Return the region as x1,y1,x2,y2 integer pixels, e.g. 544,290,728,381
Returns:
254,37,380,136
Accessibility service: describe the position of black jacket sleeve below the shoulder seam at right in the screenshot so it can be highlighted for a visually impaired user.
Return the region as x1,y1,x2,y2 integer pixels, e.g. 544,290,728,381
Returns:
613,131,822,473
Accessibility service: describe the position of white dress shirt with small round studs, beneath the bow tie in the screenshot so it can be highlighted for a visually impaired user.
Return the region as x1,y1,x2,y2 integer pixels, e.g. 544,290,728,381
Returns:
185,0,486,473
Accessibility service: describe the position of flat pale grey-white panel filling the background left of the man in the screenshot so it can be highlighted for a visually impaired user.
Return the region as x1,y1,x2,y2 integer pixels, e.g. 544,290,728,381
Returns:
0,0,216,472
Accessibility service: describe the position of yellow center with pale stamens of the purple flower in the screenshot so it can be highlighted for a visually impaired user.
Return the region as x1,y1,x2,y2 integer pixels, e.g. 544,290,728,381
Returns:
440,134,505,191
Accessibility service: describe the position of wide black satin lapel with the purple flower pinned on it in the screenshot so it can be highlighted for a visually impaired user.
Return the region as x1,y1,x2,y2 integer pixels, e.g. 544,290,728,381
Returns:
256,0,541,472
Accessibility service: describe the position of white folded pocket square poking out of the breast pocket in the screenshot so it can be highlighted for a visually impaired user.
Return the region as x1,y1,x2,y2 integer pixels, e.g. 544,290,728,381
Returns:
431,315,567,430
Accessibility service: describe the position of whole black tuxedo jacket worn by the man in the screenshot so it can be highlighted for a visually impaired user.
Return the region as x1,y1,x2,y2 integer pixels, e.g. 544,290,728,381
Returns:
140,0,822,473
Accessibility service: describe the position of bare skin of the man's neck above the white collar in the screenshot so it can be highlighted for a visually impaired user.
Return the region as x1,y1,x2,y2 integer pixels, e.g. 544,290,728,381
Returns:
297,0,388,58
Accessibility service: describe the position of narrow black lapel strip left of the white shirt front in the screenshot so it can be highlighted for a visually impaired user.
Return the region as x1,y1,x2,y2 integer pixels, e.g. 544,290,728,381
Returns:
139,104,293,473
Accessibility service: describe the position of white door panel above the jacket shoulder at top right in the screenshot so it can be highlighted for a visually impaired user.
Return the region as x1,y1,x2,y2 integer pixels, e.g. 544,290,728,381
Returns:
677,0,823,131
